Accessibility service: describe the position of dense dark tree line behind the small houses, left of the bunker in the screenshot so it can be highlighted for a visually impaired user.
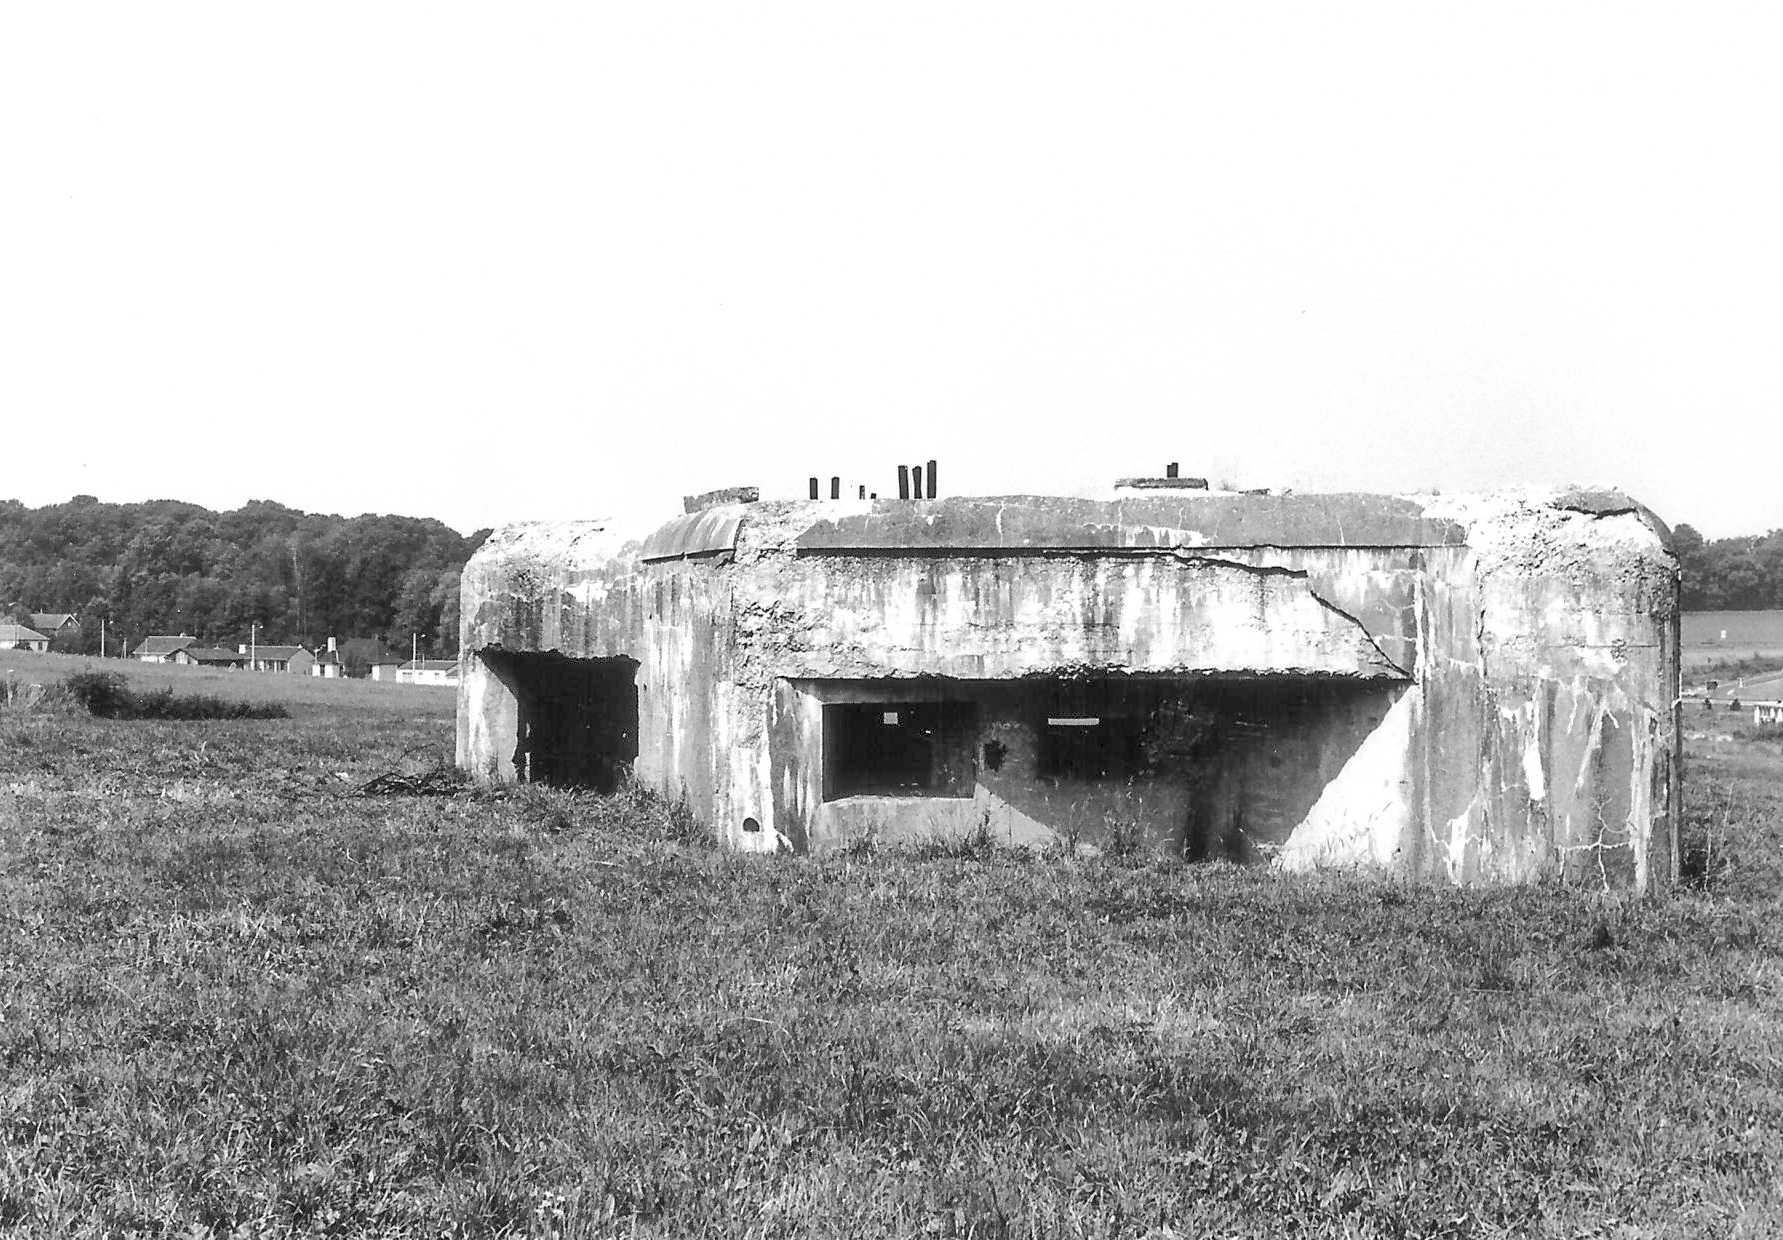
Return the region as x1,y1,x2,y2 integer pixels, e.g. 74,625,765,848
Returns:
0,496,489,657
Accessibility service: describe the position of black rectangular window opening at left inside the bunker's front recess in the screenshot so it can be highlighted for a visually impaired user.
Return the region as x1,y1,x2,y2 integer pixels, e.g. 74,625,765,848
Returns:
824,701,977,801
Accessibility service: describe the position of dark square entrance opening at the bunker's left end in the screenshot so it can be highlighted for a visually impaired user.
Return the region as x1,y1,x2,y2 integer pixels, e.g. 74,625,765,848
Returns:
494,655,638,792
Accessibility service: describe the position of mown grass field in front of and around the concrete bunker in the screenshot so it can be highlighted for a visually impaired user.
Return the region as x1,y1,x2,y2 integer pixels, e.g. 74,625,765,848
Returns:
0,655,1783,1238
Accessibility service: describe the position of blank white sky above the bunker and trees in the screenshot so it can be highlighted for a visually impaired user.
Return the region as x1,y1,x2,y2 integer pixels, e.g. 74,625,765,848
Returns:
0,0,1783,537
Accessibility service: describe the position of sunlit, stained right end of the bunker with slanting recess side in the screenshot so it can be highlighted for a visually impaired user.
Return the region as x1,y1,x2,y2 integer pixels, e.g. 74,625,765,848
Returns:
1282,498,1681,890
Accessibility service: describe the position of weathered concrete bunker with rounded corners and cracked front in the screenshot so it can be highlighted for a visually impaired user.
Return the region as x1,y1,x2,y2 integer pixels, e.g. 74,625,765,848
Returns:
458,491,1681,890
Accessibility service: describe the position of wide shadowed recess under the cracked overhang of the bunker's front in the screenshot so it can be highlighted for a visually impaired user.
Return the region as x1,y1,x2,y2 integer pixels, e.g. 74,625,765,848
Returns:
811,673,1407,862
